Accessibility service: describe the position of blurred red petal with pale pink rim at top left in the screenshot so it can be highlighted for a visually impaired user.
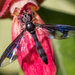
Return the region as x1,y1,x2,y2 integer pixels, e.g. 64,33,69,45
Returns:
0,0,43,18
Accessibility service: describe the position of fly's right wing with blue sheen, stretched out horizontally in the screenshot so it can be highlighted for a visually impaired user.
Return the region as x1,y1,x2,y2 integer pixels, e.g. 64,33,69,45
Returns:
36,24,75,39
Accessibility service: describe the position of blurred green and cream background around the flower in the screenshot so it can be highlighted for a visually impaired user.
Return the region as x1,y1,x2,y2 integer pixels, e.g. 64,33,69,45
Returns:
0,0,75,75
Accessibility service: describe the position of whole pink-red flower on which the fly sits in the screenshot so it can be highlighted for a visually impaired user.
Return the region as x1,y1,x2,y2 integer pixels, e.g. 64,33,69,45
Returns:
0,0,56,75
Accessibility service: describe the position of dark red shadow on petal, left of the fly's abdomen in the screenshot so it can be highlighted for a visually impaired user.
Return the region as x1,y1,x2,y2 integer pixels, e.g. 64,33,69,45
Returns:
21,45,39,68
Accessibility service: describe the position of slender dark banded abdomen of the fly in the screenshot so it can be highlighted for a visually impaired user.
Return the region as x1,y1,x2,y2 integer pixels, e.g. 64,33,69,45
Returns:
32,33,48,64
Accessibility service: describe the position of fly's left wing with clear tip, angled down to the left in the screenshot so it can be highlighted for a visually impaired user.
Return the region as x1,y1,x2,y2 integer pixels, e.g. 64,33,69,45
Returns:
0,31,24,67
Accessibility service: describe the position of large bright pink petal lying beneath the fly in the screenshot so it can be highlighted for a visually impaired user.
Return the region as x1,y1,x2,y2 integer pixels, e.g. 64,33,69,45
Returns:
12,2,56,75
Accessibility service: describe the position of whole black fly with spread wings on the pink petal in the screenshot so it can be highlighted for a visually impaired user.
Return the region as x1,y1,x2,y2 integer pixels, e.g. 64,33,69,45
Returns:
0,8,75,67
